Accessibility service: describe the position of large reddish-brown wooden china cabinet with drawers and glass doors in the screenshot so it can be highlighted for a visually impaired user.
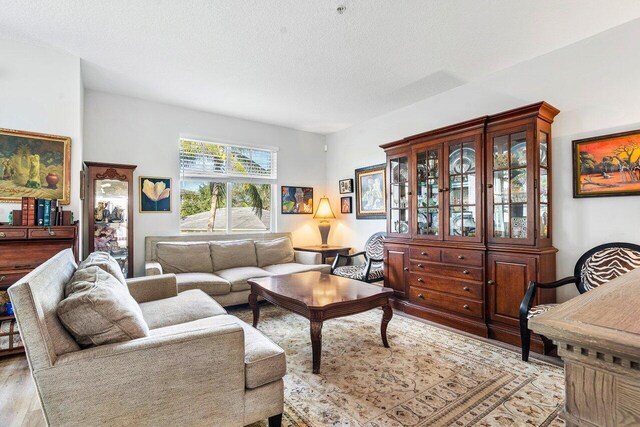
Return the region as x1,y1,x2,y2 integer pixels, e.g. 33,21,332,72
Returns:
382,102,559,352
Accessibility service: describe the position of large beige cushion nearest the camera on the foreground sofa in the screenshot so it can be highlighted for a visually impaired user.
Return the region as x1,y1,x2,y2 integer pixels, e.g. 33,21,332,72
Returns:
57,266,149,347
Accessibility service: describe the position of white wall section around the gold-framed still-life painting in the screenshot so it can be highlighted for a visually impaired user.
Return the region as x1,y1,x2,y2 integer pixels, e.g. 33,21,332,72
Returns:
0,38,84,237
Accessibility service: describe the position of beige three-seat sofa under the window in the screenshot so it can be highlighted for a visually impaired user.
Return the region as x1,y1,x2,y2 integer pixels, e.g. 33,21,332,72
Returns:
145,233,331,307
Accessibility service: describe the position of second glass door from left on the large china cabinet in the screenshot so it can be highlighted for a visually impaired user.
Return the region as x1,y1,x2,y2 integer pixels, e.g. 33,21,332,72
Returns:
415,146,442,240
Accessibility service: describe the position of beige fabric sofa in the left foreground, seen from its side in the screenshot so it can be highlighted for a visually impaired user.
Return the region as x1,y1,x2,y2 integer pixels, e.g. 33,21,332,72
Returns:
7,249,286,426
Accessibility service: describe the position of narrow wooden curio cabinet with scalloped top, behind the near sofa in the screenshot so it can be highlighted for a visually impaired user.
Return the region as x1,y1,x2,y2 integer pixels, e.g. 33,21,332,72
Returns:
84,162,136,277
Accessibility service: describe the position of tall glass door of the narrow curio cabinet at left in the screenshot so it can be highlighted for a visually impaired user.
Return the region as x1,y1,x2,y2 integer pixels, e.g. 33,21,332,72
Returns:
93,179,130,277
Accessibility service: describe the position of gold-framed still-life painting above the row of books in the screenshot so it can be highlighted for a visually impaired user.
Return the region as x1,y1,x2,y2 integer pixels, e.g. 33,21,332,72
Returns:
0,129,71,205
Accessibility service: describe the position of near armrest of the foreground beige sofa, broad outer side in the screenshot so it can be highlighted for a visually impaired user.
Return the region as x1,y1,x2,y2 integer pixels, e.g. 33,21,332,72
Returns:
34,316,245,426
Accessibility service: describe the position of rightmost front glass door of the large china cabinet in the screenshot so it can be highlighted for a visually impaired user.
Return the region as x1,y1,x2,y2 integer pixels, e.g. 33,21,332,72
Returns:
489,128,533,243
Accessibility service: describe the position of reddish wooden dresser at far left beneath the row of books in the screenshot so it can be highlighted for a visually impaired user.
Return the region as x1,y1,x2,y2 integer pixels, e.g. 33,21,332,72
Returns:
0,222,78,357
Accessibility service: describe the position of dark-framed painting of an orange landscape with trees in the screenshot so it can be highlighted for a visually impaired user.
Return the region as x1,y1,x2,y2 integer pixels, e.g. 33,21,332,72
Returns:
573,130,640,198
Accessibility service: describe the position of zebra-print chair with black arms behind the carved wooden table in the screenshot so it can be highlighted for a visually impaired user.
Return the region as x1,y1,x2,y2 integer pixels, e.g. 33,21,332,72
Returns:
520,242,640,362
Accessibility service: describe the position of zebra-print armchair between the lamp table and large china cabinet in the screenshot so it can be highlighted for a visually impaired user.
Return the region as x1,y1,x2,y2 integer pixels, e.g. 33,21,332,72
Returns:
331,232,386,283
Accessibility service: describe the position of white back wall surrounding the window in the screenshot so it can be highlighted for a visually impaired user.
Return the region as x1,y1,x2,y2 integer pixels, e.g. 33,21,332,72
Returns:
84,91,328,275
